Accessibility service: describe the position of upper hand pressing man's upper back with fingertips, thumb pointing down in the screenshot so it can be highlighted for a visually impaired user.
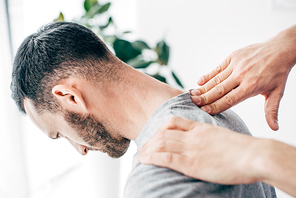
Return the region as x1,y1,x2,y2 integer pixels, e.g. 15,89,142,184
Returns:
191,26,296,130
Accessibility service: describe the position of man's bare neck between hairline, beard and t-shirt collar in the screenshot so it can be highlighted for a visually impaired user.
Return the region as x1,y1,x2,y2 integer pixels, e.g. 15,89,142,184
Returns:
98,68,183,140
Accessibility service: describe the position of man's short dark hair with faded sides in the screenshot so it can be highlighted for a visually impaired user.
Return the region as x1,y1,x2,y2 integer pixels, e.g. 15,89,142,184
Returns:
11,22,113,113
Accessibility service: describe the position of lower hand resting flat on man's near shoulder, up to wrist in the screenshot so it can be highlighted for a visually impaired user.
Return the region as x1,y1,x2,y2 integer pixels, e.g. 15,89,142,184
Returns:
138,117,261,184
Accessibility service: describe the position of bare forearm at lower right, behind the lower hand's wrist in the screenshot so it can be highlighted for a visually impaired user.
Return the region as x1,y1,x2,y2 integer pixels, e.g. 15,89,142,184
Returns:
253,140,296,196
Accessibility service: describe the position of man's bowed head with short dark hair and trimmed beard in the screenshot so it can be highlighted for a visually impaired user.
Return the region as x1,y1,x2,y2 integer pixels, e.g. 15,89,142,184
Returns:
11,22,129,157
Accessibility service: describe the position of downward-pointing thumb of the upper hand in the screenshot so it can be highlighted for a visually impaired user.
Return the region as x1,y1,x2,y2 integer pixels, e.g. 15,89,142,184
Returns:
265,87,283,131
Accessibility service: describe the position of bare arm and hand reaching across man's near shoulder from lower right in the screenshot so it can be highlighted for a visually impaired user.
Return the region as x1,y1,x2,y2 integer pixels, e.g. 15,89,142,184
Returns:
138,117,296,196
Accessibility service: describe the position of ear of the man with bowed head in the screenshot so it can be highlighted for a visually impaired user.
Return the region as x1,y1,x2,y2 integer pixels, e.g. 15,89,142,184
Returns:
52,85,87,112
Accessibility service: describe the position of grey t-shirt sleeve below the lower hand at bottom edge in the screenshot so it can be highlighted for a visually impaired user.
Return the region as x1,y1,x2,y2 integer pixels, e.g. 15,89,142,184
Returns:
124,162,244,198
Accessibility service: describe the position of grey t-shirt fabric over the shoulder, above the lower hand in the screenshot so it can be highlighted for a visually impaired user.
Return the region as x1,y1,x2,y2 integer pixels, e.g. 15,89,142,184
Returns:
136,92,250,149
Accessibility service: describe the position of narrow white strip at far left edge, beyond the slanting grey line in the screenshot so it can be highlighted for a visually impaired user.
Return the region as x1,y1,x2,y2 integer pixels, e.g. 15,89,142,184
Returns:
0,1,29,198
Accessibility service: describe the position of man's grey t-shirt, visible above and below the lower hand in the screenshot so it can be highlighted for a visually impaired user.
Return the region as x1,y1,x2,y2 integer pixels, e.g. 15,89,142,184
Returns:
124,92,276,198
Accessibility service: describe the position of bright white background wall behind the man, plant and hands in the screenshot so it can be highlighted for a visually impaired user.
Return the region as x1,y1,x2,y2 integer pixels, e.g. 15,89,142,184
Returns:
10,0,296,198
